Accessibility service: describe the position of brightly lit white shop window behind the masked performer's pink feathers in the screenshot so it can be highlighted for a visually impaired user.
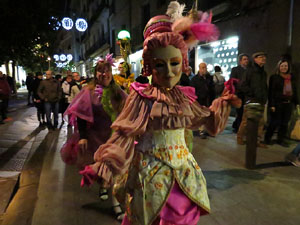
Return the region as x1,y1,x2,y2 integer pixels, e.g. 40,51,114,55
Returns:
195,36,239,80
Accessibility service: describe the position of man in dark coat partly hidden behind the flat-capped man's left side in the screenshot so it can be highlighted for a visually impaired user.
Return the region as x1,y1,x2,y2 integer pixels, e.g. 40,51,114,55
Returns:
230,53,249,133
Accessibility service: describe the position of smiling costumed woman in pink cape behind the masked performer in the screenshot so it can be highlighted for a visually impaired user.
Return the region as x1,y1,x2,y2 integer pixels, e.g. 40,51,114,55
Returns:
61,54,127,220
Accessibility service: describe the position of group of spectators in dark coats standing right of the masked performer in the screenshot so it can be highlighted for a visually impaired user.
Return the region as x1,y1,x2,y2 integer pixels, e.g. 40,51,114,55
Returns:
180,52,299,151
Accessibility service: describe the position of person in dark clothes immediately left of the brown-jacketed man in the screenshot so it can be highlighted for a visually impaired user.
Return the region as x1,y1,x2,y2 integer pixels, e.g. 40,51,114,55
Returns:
32,72,46,127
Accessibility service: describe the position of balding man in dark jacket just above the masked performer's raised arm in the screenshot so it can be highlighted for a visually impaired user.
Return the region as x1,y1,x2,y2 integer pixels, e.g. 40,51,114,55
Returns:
190,63,215,138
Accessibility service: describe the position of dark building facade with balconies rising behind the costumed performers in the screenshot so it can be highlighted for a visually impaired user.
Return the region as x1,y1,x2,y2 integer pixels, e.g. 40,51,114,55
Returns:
55,0,300,101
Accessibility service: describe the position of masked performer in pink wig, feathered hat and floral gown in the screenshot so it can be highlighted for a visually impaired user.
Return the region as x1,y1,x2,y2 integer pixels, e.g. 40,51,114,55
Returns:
84,2,241,225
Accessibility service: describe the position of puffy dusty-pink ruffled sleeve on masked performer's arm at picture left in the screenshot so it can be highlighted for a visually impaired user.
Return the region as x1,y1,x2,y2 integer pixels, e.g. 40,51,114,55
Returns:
94,90,150,184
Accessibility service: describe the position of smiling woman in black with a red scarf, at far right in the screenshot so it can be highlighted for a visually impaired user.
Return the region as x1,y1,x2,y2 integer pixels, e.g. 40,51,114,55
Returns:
265,60,298,147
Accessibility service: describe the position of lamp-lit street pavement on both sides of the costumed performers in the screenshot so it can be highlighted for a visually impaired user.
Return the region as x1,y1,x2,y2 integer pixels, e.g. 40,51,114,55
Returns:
0,92,300,225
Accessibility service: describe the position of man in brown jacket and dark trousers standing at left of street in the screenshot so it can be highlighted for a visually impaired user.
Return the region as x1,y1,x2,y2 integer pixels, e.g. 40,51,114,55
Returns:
38,70,62,130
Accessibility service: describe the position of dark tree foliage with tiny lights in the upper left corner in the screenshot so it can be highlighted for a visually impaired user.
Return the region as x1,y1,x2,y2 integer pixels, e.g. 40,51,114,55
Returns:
0,0,65,72
